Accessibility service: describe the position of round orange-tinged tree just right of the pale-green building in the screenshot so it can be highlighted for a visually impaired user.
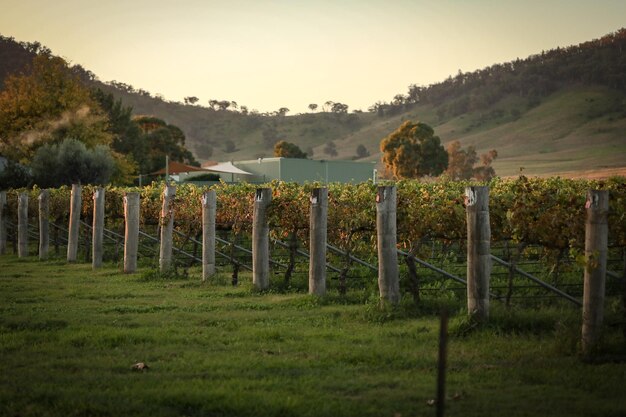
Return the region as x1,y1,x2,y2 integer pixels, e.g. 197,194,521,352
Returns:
380,120,448,179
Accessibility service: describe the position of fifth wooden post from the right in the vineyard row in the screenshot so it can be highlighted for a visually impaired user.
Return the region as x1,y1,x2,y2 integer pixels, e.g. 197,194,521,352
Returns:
252,188,272,290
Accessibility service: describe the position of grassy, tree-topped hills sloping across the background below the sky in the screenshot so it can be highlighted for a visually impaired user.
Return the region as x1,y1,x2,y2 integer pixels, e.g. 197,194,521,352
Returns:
0,29,626,175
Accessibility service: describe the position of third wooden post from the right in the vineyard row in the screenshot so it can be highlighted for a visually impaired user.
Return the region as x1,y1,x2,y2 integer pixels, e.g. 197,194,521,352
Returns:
376,186,400,304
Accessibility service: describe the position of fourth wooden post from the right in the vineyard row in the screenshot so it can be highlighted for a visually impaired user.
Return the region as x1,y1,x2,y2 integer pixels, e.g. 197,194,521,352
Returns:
309,188,328,296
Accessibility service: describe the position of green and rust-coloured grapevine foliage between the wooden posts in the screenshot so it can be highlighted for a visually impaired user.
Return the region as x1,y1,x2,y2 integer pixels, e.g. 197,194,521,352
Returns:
4,176,626,303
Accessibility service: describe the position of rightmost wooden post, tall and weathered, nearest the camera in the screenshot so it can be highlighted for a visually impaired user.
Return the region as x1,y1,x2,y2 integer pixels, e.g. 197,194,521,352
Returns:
582,190,609,355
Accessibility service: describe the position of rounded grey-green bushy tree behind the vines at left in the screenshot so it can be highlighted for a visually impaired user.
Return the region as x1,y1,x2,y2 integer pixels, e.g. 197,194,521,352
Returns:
31,139,115,188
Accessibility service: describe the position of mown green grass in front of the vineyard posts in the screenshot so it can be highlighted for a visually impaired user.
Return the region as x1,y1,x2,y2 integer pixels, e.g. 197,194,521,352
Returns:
0,255,626,417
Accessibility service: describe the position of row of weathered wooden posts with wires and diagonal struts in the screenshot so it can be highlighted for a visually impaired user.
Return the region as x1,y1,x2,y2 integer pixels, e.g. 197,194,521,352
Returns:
0,185,624,347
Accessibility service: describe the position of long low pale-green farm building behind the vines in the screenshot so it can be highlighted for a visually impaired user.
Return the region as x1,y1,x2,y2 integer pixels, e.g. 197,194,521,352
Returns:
229,158,375,183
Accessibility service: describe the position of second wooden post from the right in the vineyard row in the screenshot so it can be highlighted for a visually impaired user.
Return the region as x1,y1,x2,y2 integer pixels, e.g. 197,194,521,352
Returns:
465,186,491,322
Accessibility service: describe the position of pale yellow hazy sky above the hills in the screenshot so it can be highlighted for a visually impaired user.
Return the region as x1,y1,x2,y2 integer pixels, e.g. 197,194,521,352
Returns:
0,0,626,114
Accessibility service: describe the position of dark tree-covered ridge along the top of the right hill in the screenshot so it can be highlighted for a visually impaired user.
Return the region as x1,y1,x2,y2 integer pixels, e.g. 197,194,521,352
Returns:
368,28,626,117
